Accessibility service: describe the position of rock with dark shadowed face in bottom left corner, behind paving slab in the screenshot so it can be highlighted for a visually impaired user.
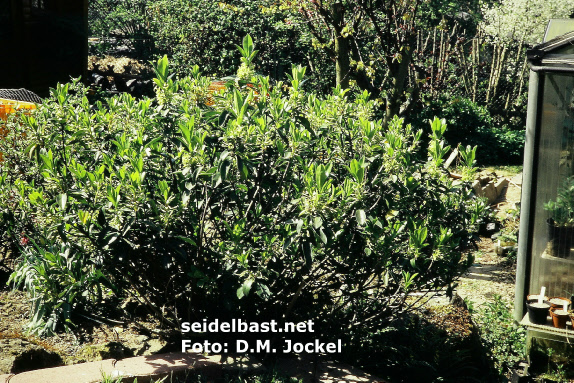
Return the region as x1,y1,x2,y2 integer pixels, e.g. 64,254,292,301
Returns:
0,338,64,374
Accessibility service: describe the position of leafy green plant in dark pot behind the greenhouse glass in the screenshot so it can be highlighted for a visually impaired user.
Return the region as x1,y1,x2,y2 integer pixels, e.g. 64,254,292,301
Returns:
544,177,574,258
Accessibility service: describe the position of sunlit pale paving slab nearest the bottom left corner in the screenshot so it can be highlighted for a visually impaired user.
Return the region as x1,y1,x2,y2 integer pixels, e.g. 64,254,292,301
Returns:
9,359,115,383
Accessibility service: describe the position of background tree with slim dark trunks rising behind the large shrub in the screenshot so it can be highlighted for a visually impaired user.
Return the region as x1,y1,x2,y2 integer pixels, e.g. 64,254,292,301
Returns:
286,0,484,124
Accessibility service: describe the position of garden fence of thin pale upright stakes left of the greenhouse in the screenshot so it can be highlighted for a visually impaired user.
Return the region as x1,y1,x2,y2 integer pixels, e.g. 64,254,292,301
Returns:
411,26,528,114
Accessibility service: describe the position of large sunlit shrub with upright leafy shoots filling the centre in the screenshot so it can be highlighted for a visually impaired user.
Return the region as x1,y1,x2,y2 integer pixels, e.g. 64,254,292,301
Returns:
0,50,483,342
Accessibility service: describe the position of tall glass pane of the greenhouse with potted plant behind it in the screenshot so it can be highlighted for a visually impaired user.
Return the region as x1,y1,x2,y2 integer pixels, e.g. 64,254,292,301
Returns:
532,74,574,298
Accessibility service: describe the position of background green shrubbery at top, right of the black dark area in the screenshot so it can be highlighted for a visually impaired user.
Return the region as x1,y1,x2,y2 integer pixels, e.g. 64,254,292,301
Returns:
90,0,335,93
